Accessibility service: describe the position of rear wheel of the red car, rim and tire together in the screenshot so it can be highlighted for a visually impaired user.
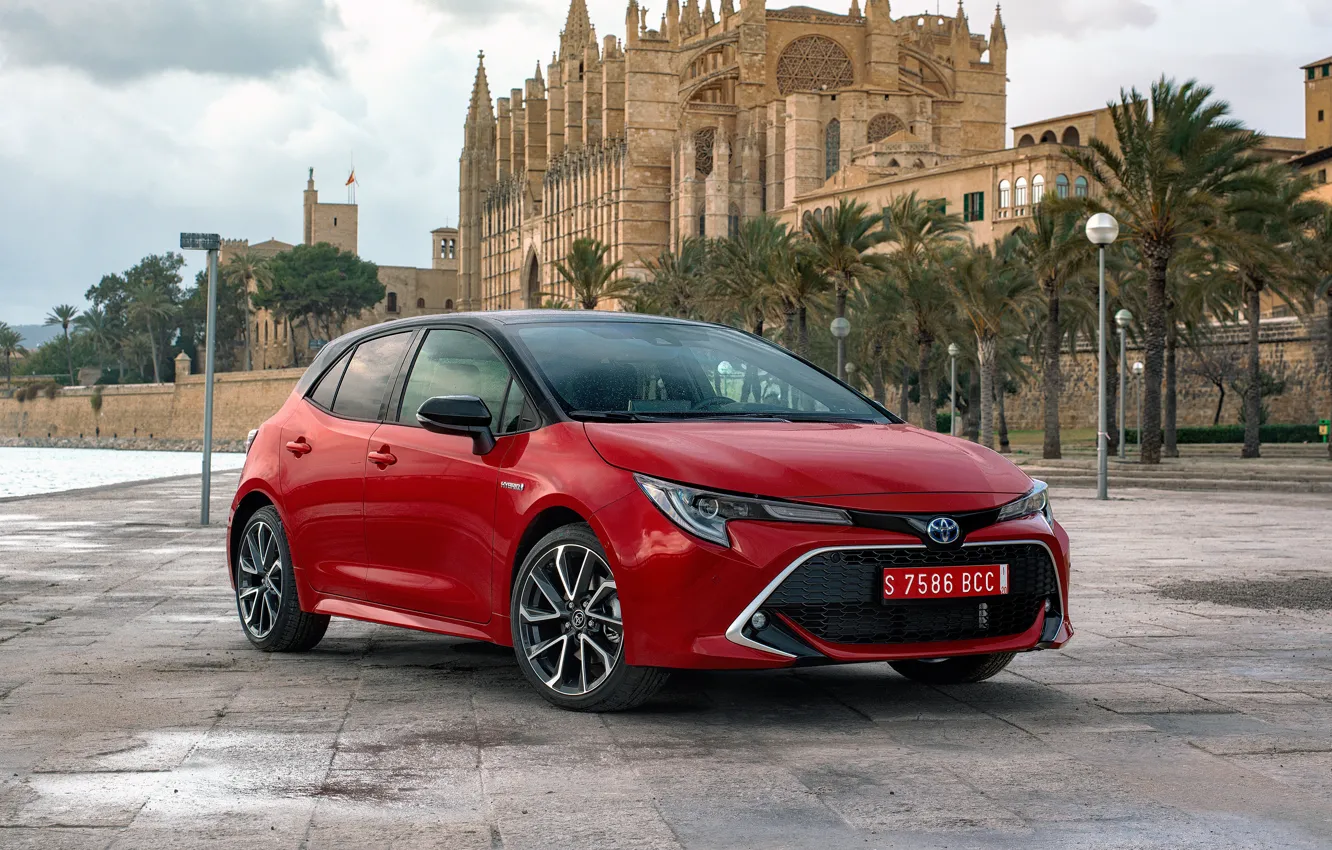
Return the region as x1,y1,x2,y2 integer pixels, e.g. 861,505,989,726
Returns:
232,506,329,653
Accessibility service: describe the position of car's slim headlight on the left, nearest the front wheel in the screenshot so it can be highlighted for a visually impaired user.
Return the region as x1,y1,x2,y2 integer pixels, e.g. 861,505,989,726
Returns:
634,474,851,546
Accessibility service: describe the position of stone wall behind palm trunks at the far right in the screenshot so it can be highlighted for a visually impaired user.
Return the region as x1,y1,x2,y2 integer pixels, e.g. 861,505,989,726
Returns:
1004,326,1332,430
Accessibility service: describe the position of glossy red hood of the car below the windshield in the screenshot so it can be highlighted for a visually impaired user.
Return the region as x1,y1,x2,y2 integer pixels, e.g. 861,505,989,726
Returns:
586,421,1031,510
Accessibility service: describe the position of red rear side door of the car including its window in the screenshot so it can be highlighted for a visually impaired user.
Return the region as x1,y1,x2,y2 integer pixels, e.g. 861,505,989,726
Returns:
280,332,413,598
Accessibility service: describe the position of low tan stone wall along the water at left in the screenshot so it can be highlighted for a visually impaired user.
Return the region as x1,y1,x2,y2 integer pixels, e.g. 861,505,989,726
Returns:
0,369,305,440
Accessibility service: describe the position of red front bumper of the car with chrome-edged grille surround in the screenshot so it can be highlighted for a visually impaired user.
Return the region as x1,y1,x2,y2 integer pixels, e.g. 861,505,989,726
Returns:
593,493,1072,669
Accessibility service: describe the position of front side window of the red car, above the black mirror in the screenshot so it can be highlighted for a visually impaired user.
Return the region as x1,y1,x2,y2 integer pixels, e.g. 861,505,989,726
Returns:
398,330,509,429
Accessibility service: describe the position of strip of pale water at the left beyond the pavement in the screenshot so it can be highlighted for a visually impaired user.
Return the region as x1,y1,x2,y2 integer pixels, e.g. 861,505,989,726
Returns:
0,448,245,498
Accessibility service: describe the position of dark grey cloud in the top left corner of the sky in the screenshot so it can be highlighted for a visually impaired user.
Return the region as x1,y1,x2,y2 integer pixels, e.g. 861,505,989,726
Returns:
0,0,332,83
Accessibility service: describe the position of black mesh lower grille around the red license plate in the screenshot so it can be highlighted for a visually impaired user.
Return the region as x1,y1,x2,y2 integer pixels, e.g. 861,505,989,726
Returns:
763,544,1059,643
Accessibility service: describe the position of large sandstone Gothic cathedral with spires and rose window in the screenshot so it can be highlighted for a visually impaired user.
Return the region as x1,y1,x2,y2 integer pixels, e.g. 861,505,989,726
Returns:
458,0,1007,309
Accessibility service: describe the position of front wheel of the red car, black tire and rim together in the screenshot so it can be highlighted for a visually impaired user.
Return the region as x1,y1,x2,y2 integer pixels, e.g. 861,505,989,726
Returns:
509,524,670,711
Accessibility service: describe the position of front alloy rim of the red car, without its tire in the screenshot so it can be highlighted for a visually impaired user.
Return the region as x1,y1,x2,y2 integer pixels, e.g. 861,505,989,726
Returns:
518,544,623,697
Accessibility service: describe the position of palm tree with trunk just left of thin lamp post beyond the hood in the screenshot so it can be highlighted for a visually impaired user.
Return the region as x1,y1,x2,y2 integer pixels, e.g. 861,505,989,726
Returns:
879,192,968,430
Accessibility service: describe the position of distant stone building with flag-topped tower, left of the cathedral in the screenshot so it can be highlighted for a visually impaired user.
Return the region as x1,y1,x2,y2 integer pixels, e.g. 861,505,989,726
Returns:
220,168,458,369
